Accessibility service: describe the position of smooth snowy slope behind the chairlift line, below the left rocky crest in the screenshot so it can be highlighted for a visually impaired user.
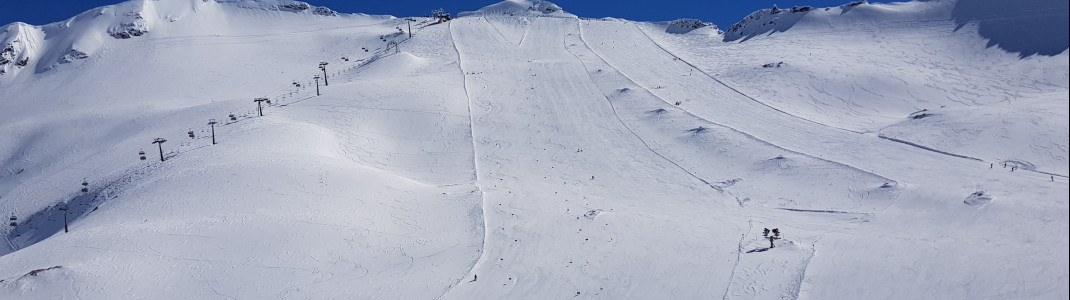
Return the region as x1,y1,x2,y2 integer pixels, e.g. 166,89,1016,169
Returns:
0,2,394,213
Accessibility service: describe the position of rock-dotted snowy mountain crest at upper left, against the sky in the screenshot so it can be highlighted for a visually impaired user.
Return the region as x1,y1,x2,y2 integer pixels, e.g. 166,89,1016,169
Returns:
0,0,366,79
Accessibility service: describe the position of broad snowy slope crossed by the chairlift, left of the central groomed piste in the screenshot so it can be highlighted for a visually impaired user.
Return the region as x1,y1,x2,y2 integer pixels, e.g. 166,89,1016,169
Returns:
0,1,482,298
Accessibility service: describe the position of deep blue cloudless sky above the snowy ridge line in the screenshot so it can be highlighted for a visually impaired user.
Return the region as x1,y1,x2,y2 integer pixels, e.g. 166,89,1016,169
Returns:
0,0,850,28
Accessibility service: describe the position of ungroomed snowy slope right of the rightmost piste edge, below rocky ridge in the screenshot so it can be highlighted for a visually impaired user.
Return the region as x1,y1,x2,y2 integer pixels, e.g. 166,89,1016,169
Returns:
644,1,1070,175
